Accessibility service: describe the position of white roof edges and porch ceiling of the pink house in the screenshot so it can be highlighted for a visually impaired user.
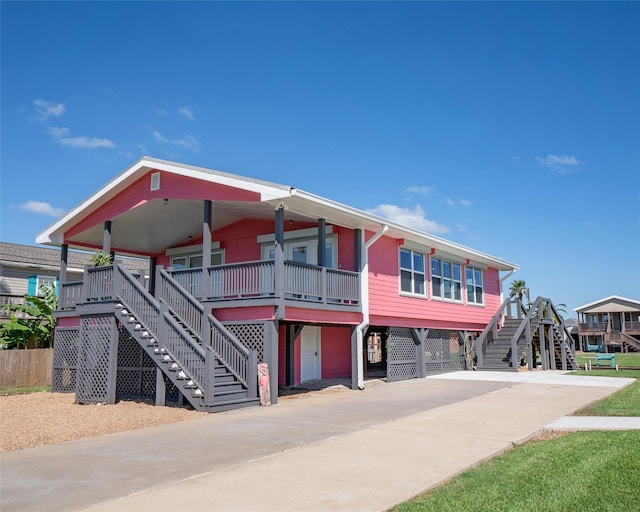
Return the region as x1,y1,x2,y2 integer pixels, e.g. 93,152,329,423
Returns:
36,157,518,271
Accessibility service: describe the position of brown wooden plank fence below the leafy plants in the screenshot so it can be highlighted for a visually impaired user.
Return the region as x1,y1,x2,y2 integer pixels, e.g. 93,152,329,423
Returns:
0,348,53,390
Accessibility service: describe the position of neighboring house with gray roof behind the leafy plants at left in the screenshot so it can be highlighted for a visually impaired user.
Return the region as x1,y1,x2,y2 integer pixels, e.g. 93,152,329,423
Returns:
0,242,144,322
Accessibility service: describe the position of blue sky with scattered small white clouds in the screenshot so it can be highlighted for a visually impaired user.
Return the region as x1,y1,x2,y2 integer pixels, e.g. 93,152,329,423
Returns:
0,1,640,316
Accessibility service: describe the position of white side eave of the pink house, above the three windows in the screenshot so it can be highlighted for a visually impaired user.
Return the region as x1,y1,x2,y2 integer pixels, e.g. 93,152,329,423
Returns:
291,189,520,270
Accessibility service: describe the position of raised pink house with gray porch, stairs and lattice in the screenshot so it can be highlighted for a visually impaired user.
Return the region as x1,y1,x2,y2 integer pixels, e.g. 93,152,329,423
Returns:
36,157,517,411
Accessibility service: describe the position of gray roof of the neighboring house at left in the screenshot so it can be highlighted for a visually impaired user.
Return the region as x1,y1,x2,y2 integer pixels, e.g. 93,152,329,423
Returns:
0,242,149,272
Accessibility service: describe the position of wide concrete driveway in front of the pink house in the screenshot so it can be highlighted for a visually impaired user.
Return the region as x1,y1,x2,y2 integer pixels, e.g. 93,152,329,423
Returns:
0,372,633,512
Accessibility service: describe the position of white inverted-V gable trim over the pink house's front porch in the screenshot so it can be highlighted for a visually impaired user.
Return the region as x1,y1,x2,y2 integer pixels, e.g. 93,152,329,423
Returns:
36,157,291,245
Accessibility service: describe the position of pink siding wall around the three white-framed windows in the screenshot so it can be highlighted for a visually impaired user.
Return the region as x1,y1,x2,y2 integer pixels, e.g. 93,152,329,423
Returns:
369,237,500,330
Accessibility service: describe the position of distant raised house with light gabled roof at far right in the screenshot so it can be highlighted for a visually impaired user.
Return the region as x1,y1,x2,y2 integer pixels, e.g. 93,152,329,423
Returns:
574,295,640,352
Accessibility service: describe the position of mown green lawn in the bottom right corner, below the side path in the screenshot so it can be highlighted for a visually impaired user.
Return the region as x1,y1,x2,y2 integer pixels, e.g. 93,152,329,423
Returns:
391,430,640,512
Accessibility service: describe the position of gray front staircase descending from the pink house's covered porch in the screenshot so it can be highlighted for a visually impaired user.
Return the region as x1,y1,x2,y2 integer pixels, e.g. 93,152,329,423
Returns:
115,266,259,412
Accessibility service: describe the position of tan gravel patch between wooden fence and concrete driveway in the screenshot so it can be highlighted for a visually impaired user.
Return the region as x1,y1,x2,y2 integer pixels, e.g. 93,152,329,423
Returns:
0,391,207,452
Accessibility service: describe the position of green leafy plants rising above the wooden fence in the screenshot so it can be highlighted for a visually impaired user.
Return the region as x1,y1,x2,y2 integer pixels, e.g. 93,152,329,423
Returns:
0,284,58,349
